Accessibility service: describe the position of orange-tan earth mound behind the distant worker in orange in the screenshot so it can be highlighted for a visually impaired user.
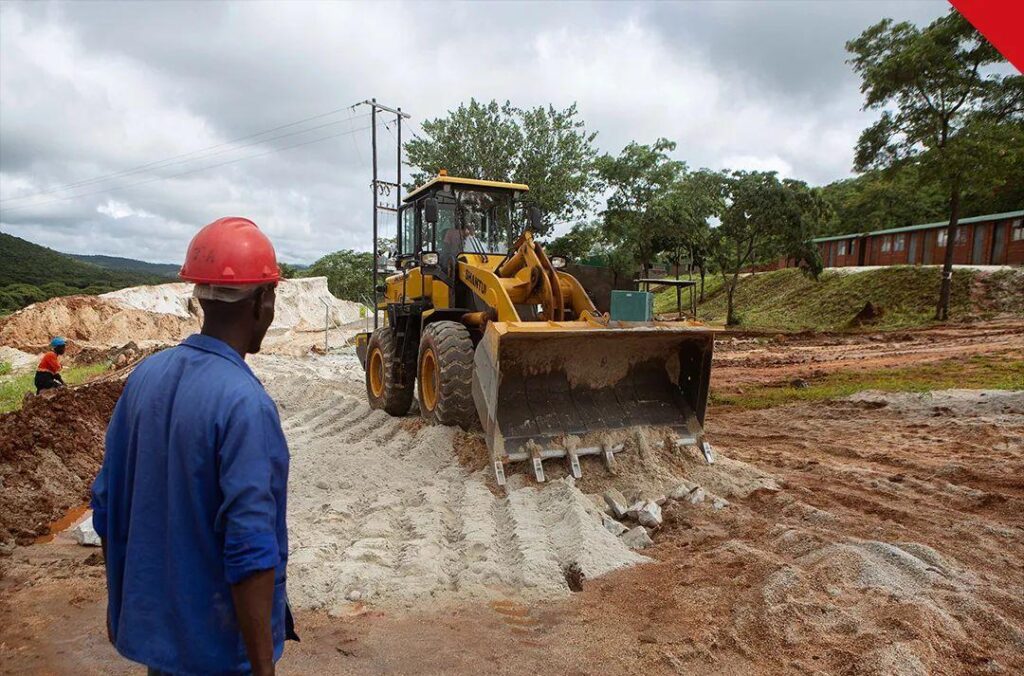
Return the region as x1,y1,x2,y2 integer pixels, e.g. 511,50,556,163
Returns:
0,296,199,351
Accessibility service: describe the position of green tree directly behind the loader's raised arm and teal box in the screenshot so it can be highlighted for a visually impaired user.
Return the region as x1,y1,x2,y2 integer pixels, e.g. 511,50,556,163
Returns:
595,138,686,277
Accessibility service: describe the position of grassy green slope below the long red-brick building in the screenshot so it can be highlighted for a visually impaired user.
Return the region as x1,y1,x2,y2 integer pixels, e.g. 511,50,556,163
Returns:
654,266,1007,331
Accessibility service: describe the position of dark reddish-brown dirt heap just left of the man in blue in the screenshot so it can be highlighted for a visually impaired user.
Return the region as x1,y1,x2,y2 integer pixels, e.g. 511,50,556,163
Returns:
0,380,124,546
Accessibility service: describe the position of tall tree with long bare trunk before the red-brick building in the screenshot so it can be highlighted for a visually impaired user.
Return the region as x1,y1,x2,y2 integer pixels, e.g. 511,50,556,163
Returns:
846,10,1024,320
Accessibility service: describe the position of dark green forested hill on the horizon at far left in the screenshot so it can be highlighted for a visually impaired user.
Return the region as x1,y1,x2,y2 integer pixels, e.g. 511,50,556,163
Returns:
0,233,167,313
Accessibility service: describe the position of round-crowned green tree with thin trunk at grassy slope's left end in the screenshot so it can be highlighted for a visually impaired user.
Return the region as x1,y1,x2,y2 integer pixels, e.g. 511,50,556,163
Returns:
712,171,830,326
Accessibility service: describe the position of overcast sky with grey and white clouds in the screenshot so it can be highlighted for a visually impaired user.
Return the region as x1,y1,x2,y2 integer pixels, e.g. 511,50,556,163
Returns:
0,0,948,262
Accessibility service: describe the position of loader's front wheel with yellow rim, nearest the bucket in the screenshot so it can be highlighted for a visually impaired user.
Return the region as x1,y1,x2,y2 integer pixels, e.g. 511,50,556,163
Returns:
417,322,476,429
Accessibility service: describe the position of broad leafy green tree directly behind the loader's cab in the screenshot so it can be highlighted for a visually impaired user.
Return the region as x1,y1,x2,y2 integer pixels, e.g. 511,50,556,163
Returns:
406,98,597,236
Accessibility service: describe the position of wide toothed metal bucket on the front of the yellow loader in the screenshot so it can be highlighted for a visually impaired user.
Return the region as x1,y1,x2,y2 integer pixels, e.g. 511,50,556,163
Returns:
473,322,714,483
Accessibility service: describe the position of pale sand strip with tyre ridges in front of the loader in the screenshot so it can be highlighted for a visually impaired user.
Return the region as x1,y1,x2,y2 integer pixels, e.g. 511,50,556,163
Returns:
252,355,647,614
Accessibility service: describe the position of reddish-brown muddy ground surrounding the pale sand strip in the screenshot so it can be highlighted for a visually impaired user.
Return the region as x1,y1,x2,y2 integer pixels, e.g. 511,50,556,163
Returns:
0,323,1024,674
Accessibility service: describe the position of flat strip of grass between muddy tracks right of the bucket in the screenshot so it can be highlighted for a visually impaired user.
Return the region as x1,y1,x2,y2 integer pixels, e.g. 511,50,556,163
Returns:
711,356,1024,409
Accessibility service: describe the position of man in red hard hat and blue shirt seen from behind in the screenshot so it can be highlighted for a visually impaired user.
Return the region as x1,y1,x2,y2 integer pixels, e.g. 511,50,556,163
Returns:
92,218,294,674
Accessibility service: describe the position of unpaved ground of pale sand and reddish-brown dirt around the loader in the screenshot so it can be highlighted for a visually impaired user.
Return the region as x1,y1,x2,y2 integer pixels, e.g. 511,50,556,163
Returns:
0,325,1024,674
